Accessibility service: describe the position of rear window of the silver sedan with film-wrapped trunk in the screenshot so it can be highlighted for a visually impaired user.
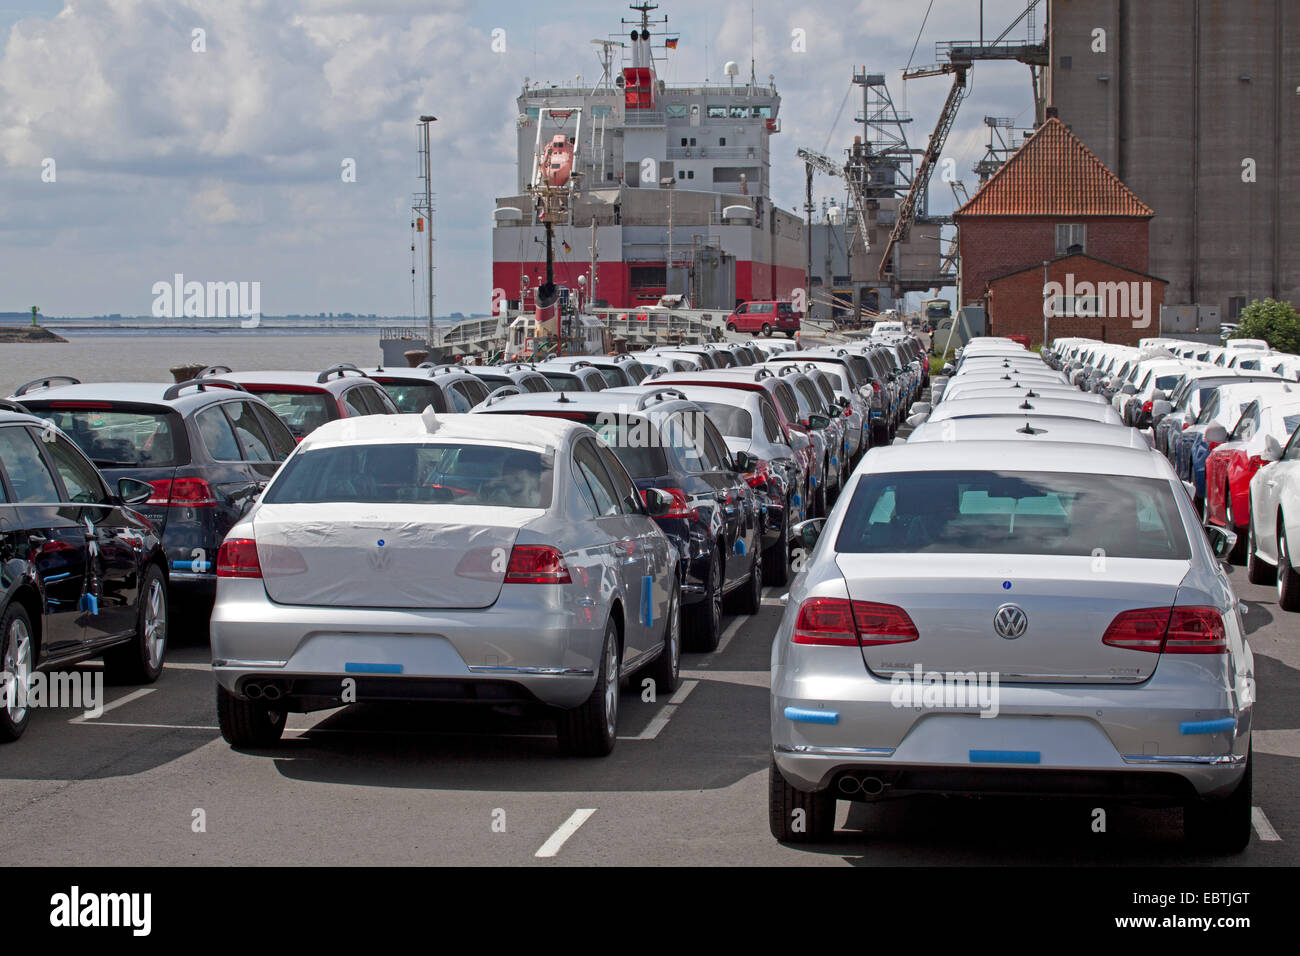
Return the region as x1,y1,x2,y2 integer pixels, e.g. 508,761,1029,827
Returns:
264,442,553,509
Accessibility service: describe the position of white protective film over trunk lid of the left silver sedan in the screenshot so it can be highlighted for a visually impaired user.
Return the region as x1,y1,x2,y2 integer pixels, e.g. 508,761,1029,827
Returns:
254,503,545,609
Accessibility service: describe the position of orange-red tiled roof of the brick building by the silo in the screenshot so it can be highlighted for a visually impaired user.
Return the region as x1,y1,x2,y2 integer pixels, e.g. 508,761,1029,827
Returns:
954,117,1156,217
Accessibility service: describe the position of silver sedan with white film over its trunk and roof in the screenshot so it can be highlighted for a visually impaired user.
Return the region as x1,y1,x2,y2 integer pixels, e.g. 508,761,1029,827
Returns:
212,410,681,756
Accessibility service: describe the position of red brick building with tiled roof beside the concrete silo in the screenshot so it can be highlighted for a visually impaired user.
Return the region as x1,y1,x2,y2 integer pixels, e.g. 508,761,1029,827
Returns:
954,111,1165,343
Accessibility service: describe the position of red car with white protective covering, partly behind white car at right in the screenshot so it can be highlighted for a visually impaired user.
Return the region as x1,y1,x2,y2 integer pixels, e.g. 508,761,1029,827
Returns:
1205,398,1300,564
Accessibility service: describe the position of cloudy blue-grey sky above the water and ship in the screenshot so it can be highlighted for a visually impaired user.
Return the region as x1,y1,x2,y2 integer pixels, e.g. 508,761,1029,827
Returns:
0,0,1045,316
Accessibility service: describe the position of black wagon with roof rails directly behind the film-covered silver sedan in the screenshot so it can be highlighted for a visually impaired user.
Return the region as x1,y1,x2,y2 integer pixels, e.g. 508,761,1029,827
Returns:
476,386,764,650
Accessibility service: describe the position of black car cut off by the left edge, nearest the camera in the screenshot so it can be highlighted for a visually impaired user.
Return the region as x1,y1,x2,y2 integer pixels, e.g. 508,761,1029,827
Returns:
0,402,168,741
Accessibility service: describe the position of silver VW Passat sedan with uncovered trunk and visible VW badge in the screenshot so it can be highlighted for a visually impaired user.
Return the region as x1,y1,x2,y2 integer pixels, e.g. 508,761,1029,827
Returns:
770,441,1255,849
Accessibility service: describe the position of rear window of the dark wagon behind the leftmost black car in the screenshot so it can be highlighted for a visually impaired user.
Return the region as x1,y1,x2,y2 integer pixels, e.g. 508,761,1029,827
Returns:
31,408,189,468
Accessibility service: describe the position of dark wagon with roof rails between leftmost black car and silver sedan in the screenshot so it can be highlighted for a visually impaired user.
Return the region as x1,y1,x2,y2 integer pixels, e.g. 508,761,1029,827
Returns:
16,376,297,597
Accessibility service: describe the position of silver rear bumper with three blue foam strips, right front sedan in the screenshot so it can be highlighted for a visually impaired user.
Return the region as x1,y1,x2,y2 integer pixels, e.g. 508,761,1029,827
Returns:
770,648,1252,801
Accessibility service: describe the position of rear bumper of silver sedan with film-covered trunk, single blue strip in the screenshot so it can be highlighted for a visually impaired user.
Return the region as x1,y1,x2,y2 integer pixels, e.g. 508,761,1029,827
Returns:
211,579,607,709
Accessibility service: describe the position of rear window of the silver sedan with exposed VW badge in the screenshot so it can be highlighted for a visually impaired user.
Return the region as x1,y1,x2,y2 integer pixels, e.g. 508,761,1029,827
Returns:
836,471,1190,561
